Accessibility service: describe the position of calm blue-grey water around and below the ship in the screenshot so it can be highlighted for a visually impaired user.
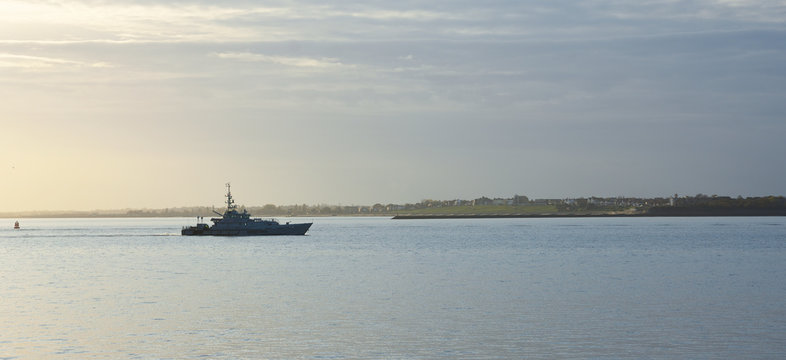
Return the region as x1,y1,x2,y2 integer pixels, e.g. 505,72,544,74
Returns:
0,217,786,359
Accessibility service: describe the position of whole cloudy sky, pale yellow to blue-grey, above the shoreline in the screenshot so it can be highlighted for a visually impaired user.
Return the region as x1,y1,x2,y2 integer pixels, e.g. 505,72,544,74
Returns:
0,0,786,211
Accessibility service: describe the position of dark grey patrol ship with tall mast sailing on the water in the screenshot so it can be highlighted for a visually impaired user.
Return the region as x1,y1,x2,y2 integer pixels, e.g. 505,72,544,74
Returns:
180,183,313,236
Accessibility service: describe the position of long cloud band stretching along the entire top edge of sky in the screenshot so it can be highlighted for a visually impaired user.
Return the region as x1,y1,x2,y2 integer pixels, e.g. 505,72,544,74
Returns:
0,0,786,44
